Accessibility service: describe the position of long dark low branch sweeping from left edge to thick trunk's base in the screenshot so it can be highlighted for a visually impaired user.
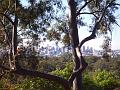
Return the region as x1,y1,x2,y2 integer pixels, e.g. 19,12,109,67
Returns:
0,65,70,90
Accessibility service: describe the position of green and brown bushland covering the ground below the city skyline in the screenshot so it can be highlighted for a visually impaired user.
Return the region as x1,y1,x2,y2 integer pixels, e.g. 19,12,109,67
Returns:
0,55,120,90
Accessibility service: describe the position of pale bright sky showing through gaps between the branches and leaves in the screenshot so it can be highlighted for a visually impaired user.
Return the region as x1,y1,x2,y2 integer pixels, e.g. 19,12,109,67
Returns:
21,0,120,49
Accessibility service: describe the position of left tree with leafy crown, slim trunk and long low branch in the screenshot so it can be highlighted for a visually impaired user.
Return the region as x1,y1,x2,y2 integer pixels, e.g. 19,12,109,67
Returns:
0,0,69,90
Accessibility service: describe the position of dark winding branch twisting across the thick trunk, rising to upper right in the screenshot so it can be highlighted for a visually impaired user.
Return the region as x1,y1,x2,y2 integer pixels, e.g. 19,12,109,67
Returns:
69,2,115,84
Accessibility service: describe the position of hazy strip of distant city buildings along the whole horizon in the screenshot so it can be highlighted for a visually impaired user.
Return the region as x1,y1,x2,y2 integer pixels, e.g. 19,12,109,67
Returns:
0,44,120,57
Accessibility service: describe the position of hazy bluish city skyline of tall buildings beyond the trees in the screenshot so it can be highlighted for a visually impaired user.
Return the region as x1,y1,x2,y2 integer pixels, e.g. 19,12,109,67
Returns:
28,45,120,57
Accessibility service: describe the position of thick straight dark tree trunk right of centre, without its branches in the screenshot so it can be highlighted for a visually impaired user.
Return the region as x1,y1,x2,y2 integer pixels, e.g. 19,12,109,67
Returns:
68,0,82,90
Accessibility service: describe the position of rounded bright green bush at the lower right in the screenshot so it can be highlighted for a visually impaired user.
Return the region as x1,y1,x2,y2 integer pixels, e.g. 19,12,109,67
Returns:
93,70,117,90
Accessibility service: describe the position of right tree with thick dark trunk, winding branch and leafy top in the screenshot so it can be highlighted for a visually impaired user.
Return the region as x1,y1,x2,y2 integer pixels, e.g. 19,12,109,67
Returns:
68,0,119,90
